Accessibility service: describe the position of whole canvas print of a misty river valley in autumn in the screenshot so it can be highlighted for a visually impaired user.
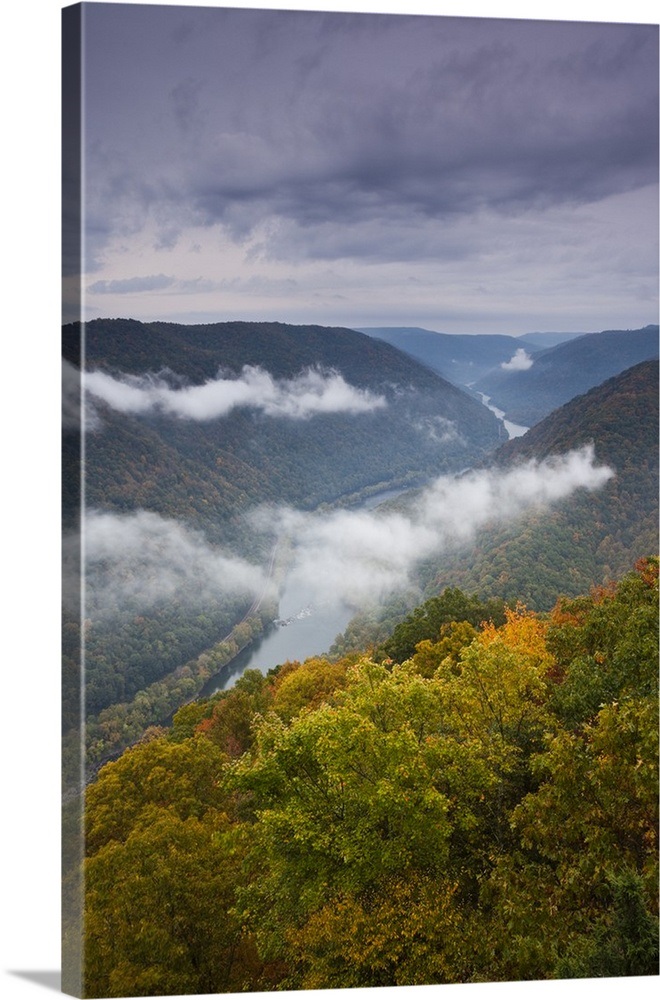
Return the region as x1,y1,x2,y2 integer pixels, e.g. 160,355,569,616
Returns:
62,3,658,997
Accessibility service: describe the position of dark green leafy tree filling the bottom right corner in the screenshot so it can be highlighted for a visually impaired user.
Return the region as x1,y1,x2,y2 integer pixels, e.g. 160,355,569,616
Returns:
482,698,658,979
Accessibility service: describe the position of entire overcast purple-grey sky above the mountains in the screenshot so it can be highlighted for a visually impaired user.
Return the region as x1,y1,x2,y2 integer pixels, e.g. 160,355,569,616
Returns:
68,4,658,334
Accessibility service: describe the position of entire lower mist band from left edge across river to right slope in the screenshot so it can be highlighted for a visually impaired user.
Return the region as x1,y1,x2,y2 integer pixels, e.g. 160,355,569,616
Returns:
78,447,614,617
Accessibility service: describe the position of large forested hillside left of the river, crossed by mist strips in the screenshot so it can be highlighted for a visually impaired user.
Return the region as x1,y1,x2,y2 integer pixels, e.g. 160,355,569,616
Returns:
63,319,500,784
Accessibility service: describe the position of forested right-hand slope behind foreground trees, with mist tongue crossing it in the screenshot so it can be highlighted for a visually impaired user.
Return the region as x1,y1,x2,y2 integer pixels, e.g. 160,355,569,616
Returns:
425,361,658,610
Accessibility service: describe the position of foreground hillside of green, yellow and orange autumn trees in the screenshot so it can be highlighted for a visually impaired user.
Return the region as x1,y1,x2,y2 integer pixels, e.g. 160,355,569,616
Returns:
65,559,658,997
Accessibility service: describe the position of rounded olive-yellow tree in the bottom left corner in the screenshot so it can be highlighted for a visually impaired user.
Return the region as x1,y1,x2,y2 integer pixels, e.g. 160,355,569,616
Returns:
84,806,260,997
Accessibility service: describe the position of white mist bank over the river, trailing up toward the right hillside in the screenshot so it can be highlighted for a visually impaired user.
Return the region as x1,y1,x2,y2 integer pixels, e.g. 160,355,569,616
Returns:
257,447,614,606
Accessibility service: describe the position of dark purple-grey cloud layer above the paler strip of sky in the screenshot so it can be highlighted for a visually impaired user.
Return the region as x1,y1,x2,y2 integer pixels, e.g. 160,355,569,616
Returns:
88,5,658,256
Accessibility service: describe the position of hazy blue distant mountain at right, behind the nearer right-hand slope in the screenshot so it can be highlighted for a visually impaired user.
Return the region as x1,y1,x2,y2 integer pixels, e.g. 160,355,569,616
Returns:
475,326,658,427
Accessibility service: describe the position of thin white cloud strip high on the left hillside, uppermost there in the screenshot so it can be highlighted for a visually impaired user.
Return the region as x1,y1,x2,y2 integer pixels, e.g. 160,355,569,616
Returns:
85,365,387,421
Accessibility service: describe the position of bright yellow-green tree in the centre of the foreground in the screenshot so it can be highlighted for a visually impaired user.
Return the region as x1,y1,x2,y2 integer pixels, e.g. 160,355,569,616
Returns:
230,661,524,988
